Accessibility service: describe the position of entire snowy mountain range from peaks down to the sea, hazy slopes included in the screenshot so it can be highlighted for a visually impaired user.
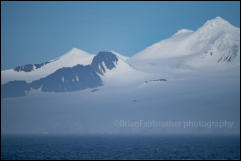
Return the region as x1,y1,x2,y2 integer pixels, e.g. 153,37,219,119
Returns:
1,17,240,135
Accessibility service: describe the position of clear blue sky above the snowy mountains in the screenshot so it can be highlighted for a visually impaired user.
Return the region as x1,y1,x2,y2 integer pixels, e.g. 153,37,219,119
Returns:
1,1,240,70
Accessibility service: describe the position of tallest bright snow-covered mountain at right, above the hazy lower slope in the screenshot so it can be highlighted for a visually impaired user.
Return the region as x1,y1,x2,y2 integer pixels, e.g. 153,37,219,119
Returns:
128,17,240,71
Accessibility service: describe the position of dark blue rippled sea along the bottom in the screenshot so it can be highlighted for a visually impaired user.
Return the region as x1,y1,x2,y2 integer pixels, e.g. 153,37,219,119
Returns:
1,136,240,160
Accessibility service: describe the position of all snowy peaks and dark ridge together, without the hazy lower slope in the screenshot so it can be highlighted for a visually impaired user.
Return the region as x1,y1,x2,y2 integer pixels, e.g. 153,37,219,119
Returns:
1,17,240,97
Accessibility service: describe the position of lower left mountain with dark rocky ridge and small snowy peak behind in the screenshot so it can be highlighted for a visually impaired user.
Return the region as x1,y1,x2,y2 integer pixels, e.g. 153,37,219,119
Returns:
2,51,141,97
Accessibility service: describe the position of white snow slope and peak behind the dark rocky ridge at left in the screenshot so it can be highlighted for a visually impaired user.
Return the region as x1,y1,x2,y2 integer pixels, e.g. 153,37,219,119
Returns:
1,48,95,84
